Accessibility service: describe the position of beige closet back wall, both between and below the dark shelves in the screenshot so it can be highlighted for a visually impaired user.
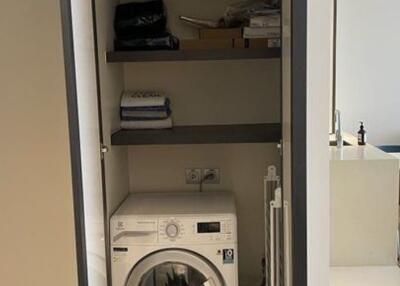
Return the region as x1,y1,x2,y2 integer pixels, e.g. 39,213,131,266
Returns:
124,60,280,285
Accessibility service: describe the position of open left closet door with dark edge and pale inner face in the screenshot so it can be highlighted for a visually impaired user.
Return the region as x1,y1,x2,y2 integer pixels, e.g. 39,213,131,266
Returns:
61,0,107,286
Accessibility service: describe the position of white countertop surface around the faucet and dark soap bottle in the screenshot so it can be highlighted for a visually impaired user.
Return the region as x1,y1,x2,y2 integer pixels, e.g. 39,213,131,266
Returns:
329,133,400,164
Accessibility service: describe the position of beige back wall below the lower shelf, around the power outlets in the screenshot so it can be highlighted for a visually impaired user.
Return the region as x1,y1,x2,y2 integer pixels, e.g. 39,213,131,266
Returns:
129,144,280,285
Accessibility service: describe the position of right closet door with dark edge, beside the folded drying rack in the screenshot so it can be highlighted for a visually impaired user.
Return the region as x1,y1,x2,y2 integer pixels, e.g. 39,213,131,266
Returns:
282,0,307,286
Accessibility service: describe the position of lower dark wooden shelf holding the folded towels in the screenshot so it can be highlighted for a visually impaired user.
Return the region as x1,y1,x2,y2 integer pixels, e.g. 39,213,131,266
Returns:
111,123,282,145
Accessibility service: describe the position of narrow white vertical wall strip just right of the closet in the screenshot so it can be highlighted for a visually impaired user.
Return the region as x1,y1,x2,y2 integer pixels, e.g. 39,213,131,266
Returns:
306,0,333,286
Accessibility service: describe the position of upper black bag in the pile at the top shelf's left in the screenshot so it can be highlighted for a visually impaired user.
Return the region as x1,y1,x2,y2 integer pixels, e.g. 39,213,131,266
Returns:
114,0,167,40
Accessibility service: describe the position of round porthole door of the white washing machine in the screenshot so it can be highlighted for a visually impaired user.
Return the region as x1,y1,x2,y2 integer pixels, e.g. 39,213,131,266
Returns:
126,249,225,286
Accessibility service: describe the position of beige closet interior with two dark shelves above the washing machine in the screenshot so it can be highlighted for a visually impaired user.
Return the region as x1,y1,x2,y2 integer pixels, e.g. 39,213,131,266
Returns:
95,0,281,286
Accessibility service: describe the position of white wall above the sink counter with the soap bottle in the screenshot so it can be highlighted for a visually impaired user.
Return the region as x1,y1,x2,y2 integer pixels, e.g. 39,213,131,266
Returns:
336,0,400,145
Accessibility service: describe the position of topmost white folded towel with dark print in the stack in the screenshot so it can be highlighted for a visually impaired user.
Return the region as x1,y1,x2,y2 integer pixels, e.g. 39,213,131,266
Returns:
121,91,167,107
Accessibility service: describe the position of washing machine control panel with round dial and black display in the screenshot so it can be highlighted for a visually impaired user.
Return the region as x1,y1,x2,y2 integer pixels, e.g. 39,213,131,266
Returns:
158,216,236,243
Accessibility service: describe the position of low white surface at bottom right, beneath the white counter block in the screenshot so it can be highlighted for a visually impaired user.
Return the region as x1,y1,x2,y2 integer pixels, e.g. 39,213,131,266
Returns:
329,266,400,286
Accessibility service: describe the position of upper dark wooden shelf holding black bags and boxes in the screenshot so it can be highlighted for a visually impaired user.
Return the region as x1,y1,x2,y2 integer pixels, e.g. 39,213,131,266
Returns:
107,48,281,63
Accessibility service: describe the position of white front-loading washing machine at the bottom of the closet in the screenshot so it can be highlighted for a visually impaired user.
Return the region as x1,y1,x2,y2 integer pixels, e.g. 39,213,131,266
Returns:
111,192,239,286
